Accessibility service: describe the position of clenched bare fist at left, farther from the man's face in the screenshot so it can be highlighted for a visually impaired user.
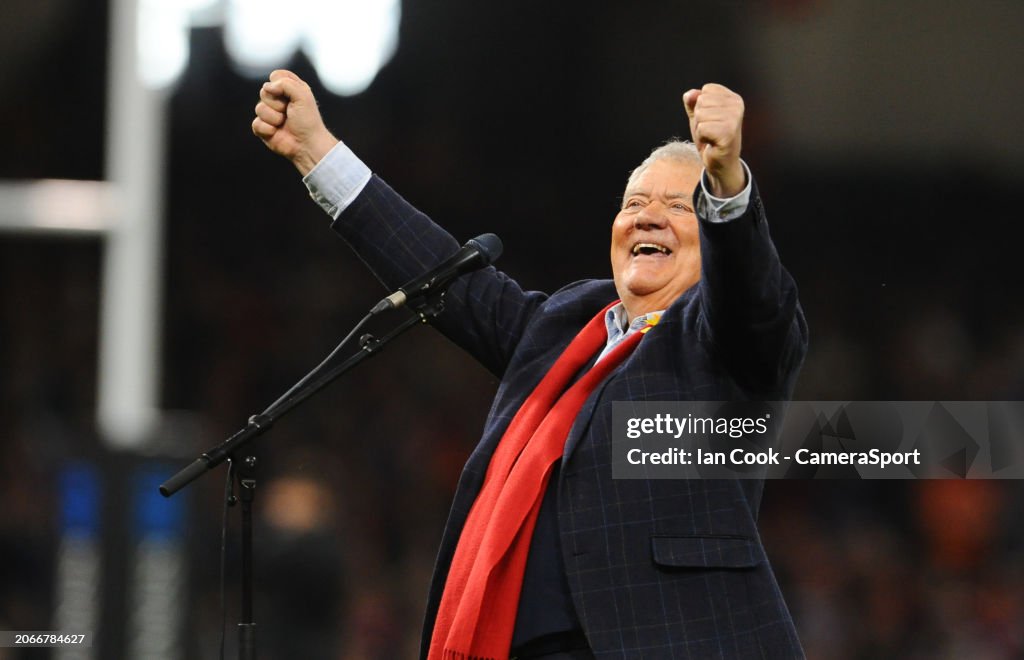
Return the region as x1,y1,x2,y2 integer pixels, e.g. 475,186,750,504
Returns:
253,69,338,176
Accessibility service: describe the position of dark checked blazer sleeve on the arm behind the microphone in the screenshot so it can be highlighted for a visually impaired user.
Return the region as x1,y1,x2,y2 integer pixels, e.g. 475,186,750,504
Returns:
332,176,547,377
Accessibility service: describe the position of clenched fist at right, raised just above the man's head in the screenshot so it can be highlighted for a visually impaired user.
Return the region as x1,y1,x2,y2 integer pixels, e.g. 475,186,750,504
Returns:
683,83,746,197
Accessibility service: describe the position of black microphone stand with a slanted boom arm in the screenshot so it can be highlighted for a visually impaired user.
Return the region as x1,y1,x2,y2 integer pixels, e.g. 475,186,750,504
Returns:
160,292,444,660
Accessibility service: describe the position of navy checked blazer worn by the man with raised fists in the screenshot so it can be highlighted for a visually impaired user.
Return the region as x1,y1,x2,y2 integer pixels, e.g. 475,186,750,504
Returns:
333,176,807,660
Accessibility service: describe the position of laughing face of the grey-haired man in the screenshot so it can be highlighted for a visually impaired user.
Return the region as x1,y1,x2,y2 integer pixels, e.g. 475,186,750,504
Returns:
611,159,701,319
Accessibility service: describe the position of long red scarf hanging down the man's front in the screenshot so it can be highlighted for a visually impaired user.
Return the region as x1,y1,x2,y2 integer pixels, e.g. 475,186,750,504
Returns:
428,301,649,660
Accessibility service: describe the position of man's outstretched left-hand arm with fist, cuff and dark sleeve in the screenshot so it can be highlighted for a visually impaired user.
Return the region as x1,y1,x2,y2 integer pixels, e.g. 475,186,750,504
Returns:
252,71,546,375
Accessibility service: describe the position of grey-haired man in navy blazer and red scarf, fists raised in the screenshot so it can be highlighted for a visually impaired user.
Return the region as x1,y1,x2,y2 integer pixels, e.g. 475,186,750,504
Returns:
252,71,807,660
